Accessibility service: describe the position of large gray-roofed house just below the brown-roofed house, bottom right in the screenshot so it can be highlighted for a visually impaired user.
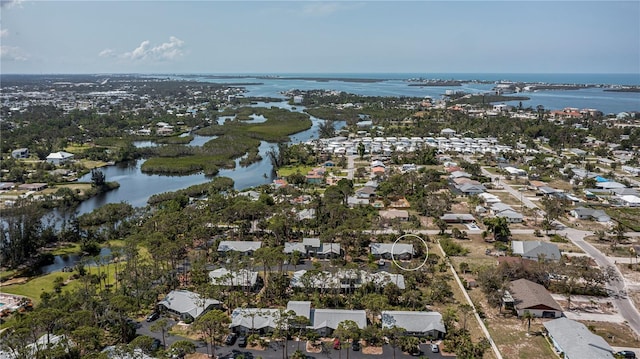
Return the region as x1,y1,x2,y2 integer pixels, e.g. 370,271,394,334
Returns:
542,318,614,359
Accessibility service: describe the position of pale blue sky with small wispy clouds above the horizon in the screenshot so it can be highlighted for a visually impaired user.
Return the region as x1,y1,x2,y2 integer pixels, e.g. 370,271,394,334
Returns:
0,0,640,73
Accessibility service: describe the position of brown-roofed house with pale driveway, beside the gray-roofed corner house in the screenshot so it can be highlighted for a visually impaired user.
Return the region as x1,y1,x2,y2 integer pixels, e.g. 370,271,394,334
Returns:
502,279,562,318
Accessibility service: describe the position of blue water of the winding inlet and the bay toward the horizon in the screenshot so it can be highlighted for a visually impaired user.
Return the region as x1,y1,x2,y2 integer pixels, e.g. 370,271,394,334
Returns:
53,74,640,218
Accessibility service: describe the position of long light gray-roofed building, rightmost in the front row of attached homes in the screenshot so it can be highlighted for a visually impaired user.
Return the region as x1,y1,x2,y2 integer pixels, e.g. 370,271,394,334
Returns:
381,311,447,339
